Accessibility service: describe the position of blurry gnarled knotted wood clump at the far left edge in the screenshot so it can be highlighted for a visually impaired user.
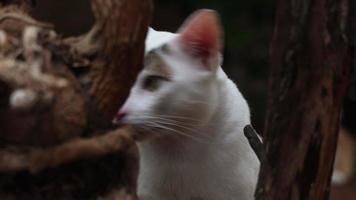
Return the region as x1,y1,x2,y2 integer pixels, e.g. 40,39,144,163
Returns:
0,13,86,146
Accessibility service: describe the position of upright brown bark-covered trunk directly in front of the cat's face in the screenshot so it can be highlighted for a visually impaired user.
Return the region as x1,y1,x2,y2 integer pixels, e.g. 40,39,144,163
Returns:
90,0,153,121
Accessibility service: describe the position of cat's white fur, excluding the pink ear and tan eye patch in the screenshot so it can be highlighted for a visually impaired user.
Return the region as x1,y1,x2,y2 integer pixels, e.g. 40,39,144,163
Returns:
121,29,259,200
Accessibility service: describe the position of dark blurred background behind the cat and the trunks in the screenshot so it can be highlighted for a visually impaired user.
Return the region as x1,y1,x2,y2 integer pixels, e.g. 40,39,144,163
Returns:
34,0,356,200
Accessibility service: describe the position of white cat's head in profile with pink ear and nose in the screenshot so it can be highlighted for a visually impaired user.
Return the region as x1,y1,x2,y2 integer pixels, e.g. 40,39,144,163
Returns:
116,10,223,138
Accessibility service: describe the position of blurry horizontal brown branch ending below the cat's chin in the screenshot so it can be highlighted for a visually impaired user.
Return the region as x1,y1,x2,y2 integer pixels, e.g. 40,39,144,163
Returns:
0,129,134,174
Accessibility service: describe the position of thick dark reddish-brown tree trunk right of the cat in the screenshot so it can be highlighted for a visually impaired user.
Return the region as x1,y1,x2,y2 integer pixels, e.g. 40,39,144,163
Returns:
256,0,353,200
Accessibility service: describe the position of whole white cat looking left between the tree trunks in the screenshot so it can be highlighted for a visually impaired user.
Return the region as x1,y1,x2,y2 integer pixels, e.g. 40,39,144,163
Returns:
117,10,260,200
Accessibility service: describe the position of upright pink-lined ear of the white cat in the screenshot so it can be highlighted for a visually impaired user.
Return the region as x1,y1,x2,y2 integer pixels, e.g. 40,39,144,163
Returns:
178,9,223,70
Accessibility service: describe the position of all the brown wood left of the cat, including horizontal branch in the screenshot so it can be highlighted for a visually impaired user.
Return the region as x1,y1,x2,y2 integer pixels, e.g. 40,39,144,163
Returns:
0,0,152,199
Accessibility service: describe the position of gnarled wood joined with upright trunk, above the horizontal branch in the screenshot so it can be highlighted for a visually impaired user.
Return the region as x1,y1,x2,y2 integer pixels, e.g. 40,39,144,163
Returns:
0,0,152,145
